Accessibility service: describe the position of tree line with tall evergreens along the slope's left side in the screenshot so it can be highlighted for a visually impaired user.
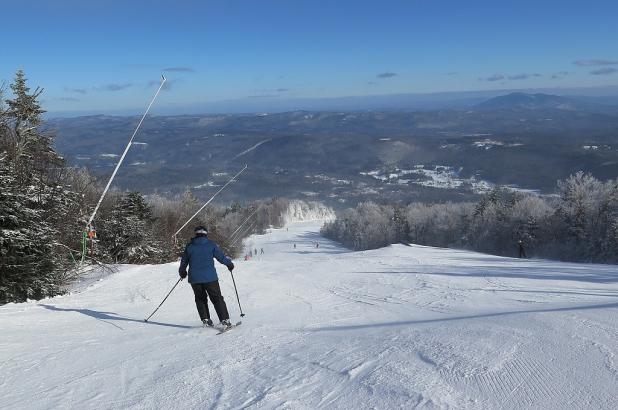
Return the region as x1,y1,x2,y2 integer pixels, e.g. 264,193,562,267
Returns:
0,70,289,304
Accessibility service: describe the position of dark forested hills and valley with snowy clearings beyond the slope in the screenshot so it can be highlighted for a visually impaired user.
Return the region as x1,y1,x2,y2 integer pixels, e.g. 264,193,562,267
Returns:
49,106,618,207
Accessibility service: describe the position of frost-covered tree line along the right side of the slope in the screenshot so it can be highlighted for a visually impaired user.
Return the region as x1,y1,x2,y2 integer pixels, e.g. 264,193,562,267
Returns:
322,172,618,263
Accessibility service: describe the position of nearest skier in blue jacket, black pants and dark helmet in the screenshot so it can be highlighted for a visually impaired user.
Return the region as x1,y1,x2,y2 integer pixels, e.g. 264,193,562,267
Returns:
178,226,234,328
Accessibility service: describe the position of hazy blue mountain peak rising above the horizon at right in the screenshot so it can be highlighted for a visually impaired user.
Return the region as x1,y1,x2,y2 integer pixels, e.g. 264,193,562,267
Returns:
474,92,584,111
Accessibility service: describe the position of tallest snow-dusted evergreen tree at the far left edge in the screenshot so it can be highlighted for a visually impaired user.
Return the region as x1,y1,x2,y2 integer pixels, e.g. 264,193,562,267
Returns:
0,71,79,303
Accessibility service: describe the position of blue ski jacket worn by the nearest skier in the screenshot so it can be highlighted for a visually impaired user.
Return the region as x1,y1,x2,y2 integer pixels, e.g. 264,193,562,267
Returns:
178,236,232,283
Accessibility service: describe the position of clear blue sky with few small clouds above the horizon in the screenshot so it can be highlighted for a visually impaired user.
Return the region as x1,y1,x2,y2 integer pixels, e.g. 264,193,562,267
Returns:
0,0,618,111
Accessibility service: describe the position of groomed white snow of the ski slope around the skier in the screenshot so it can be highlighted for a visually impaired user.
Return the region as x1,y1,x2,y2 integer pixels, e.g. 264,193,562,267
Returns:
0,222,618,410
